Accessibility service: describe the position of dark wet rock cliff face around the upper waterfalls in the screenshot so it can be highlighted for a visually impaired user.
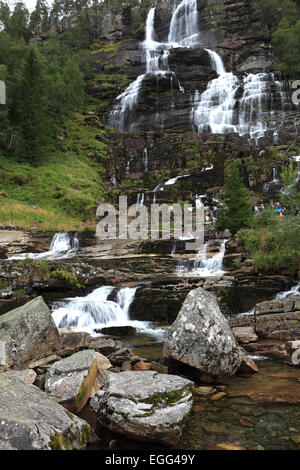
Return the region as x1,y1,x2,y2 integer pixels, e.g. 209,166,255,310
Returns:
84,0,296,203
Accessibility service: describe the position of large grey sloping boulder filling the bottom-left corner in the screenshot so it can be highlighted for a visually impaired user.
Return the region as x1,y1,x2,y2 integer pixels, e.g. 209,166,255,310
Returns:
0,374,91,450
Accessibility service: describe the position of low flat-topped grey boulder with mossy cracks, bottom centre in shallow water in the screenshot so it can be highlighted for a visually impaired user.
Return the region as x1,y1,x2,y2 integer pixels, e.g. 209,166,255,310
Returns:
90,371,194,445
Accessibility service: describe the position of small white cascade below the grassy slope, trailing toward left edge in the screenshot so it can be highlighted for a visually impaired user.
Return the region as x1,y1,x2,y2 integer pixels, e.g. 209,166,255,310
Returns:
8,232,79,260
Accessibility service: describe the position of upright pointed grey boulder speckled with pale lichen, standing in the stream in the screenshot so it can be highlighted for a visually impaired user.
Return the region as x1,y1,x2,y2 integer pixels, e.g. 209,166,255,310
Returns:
163,287,243,377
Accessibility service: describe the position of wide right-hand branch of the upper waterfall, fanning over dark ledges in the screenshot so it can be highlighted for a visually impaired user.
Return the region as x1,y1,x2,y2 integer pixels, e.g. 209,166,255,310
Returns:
191,57,289,145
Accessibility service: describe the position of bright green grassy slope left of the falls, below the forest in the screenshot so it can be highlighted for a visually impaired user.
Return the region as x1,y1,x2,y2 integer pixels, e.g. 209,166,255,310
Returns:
0,115,107,231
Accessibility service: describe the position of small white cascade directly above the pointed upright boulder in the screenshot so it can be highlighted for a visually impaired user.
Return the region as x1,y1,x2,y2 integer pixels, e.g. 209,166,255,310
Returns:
176,240,228,277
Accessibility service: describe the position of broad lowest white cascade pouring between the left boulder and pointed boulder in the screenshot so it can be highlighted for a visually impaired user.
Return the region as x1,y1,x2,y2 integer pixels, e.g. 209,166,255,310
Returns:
52,286,162,336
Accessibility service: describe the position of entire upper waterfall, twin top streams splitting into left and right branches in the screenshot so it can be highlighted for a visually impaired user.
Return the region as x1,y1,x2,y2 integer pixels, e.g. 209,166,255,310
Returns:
109,0,290,145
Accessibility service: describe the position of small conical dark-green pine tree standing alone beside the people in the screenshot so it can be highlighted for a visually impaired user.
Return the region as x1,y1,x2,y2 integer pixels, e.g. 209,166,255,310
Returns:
216,166,252,234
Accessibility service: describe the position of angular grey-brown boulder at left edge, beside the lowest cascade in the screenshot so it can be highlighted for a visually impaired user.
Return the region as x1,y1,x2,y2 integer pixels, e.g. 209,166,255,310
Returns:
0,297,61,369
